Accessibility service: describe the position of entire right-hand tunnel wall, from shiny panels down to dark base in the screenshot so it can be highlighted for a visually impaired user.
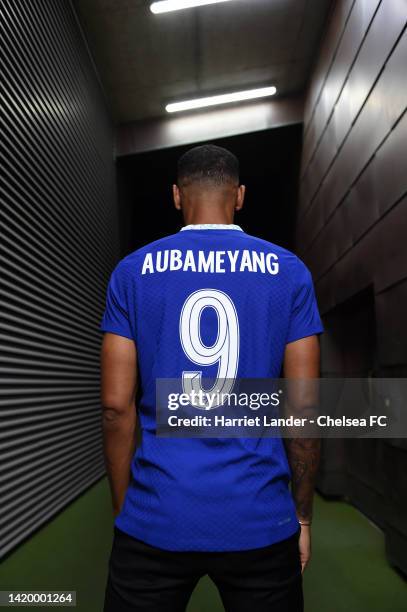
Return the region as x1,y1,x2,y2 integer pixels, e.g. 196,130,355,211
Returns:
297,0,407,572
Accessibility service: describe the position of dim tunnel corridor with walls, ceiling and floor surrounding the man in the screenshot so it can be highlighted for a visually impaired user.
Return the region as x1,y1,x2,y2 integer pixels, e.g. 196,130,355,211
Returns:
0,0,407,612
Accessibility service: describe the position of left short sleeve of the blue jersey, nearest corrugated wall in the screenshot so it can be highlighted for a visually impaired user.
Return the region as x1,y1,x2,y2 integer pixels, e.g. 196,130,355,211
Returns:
99,263,134,340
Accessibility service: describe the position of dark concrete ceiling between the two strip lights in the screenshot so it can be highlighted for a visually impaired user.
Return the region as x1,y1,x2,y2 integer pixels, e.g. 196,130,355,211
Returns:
75,0,331,123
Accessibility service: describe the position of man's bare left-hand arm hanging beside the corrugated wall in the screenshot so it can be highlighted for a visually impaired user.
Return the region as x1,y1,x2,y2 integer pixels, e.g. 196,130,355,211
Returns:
101,333,137,516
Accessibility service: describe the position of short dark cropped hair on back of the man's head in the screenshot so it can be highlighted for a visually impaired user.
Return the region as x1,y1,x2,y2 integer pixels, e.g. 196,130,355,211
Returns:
177,144,239,186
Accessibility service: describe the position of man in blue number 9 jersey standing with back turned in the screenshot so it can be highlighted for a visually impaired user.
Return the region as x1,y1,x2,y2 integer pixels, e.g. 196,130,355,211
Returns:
101,145,322,612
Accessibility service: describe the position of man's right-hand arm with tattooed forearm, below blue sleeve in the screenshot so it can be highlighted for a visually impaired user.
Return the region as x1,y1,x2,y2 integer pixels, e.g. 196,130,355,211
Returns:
284,336,320,570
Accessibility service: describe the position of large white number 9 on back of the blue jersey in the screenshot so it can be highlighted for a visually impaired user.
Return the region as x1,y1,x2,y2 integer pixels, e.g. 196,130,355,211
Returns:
179,289,239,409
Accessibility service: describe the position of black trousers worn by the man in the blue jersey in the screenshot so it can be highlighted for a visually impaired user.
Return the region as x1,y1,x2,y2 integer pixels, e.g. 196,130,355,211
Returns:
104,527,303,612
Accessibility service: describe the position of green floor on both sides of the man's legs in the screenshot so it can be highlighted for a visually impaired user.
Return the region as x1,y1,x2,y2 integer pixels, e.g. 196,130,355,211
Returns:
0,479,407,612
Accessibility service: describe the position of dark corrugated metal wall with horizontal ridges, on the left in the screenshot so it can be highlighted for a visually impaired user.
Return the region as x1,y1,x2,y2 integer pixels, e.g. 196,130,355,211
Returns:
0,0,119,555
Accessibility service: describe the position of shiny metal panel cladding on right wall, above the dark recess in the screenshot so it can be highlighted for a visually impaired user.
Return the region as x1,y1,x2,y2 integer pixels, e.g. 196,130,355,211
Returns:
297,0,407,322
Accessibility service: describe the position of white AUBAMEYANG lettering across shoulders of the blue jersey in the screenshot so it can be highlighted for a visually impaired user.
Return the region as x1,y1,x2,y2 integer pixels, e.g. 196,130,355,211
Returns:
141,249,279,274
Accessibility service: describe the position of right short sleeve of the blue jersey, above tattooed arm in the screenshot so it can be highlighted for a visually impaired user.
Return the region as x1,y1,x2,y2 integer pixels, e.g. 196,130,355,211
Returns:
287,259,324,343
